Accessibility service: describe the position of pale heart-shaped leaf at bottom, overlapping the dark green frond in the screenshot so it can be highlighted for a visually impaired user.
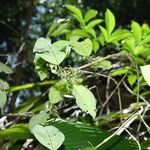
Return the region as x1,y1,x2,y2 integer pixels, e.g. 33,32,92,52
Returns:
32,124,65,150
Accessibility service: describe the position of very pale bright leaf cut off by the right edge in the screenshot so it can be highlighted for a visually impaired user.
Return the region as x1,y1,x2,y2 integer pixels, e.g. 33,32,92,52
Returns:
140,65,150,86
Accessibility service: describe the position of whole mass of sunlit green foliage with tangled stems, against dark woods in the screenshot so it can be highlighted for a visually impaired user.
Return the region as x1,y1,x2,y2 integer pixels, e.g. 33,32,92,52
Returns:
0,5,150,150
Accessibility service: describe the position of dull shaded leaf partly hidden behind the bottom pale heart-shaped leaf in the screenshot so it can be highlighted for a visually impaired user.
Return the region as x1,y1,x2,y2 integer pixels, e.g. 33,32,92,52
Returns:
29,112,49,133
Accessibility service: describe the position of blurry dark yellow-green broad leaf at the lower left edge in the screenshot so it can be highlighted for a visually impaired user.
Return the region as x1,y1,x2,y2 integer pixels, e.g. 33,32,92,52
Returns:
0,124,32,140
